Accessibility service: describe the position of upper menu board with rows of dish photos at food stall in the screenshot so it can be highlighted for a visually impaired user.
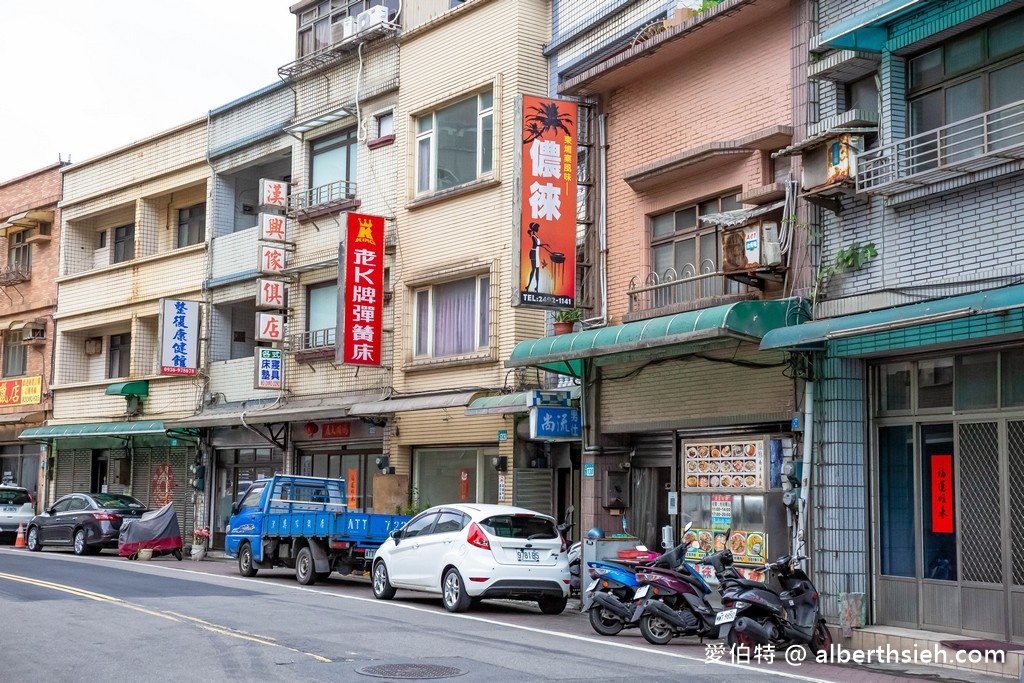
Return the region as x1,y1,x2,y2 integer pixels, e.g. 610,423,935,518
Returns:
683,440,765,490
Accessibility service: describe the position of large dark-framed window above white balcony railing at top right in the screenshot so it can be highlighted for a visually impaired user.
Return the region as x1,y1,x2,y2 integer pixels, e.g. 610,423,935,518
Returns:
907,14,1024,137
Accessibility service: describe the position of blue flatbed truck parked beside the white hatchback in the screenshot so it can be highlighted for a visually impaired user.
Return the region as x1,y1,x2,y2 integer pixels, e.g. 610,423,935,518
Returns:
224,474,412,586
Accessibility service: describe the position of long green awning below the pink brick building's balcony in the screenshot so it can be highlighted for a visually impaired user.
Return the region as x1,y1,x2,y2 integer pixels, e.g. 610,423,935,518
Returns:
505,298,804,377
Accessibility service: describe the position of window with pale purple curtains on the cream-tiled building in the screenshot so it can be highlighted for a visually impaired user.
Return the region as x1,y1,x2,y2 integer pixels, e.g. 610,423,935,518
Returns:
414,275,490,357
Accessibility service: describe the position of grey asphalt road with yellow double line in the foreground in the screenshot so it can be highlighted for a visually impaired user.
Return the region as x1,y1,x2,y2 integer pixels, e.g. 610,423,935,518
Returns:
0,548,1005,683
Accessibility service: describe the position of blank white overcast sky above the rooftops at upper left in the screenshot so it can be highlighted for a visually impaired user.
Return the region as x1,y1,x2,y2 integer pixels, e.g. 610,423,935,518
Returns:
0,0,295,182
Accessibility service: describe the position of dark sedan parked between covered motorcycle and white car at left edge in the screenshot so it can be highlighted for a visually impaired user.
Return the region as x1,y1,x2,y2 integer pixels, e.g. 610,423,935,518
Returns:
26,494,148,555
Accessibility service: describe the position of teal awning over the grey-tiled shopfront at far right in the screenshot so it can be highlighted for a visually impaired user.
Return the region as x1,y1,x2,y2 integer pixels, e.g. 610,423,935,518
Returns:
761,285,1024,355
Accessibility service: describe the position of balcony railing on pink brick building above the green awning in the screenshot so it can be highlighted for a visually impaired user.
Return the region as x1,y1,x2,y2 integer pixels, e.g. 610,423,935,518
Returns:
628,260,743,313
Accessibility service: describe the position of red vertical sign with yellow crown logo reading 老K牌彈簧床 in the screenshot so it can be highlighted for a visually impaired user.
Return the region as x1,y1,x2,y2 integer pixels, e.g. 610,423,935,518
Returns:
337,213,384,366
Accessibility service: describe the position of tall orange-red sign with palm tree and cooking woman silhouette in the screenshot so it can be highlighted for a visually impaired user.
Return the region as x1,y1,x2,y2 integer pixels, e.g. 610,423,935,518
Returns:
516,95,577,308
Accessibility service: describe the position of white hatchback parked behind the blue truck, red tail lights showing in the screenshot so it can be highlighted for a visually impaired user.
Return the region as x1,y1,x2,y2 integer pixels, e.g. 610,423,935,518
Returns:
373,503,569,614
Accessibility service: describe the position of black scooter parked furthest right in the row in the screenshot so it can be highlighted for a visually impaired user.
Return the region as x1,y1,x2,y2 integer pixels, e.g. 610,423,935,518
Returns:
705,553,833,652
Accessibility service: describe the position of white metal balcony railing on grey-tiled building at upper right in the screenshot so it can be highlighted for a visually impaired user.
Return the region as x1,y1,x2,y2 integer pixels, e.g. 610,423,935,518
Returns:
857,100,1024,195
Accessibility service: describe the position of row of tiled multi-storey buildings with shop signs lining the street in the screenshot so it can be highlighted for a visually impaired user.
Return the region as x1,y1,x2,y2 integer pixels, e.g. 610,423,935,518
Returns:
0,0,1024,671
